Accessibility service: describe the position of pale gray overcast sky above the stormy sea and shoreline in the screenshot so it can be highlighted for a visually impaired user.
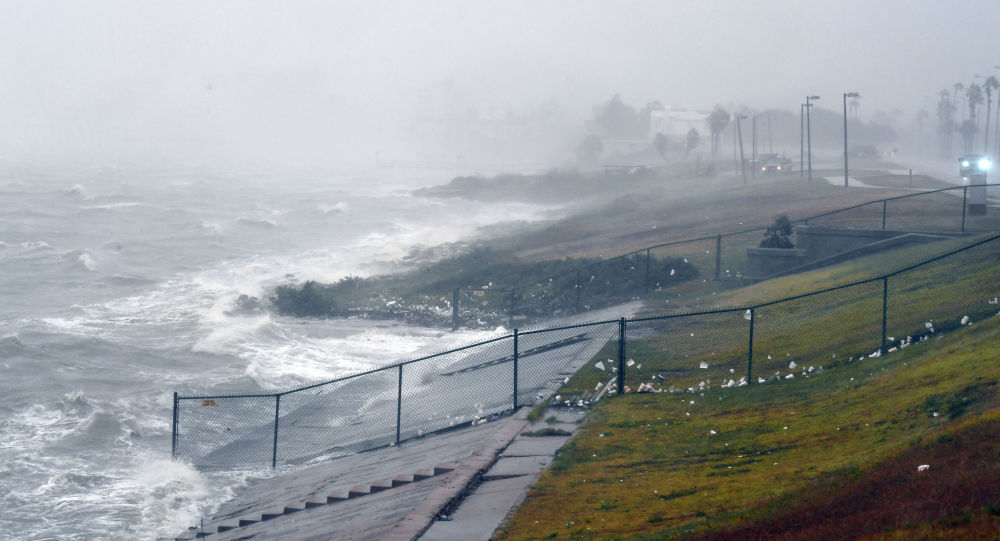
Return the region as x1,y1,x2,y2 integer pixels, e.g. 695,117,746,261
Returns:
0,0,1000,167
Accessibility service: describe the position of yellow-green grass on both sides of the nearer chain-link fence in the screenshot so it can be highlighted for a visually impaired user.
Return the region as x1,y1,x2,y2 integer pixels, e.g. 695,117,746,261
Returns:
499,240,1000,540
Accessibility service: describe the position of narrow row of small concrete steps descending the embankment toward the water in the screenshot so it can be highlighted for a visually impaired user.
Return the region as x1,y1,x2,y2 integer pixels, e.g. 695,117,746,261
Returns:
173,462,458,541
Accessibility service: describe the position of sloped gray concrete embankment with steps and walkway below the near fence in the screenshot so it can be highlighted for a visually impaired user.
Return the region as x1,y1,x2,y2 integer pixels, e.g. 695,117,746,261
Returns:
168,408,586,541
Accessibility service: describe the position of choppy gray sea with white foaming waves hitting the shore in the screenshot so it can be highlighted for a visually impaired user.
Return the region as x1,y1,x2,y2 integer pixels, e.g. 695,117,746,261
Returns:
0,163,546,539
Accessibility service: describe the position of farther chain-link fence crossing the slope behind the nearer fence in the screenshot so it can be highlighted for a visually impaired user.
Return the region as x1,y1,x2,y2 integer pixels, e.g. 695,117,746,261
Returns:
451,184,1000,329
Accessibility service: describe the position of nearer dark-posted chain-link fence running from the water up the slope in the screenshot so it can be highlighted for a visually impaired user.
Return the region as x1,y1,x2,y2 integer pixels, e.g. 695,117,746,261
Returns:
173,235,1000,468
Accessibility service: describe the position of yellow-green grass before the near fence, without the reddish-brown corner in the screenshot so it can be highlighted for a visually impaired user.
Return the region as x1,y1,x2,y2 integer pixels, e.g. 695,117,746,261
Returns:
500,318,1000,540
